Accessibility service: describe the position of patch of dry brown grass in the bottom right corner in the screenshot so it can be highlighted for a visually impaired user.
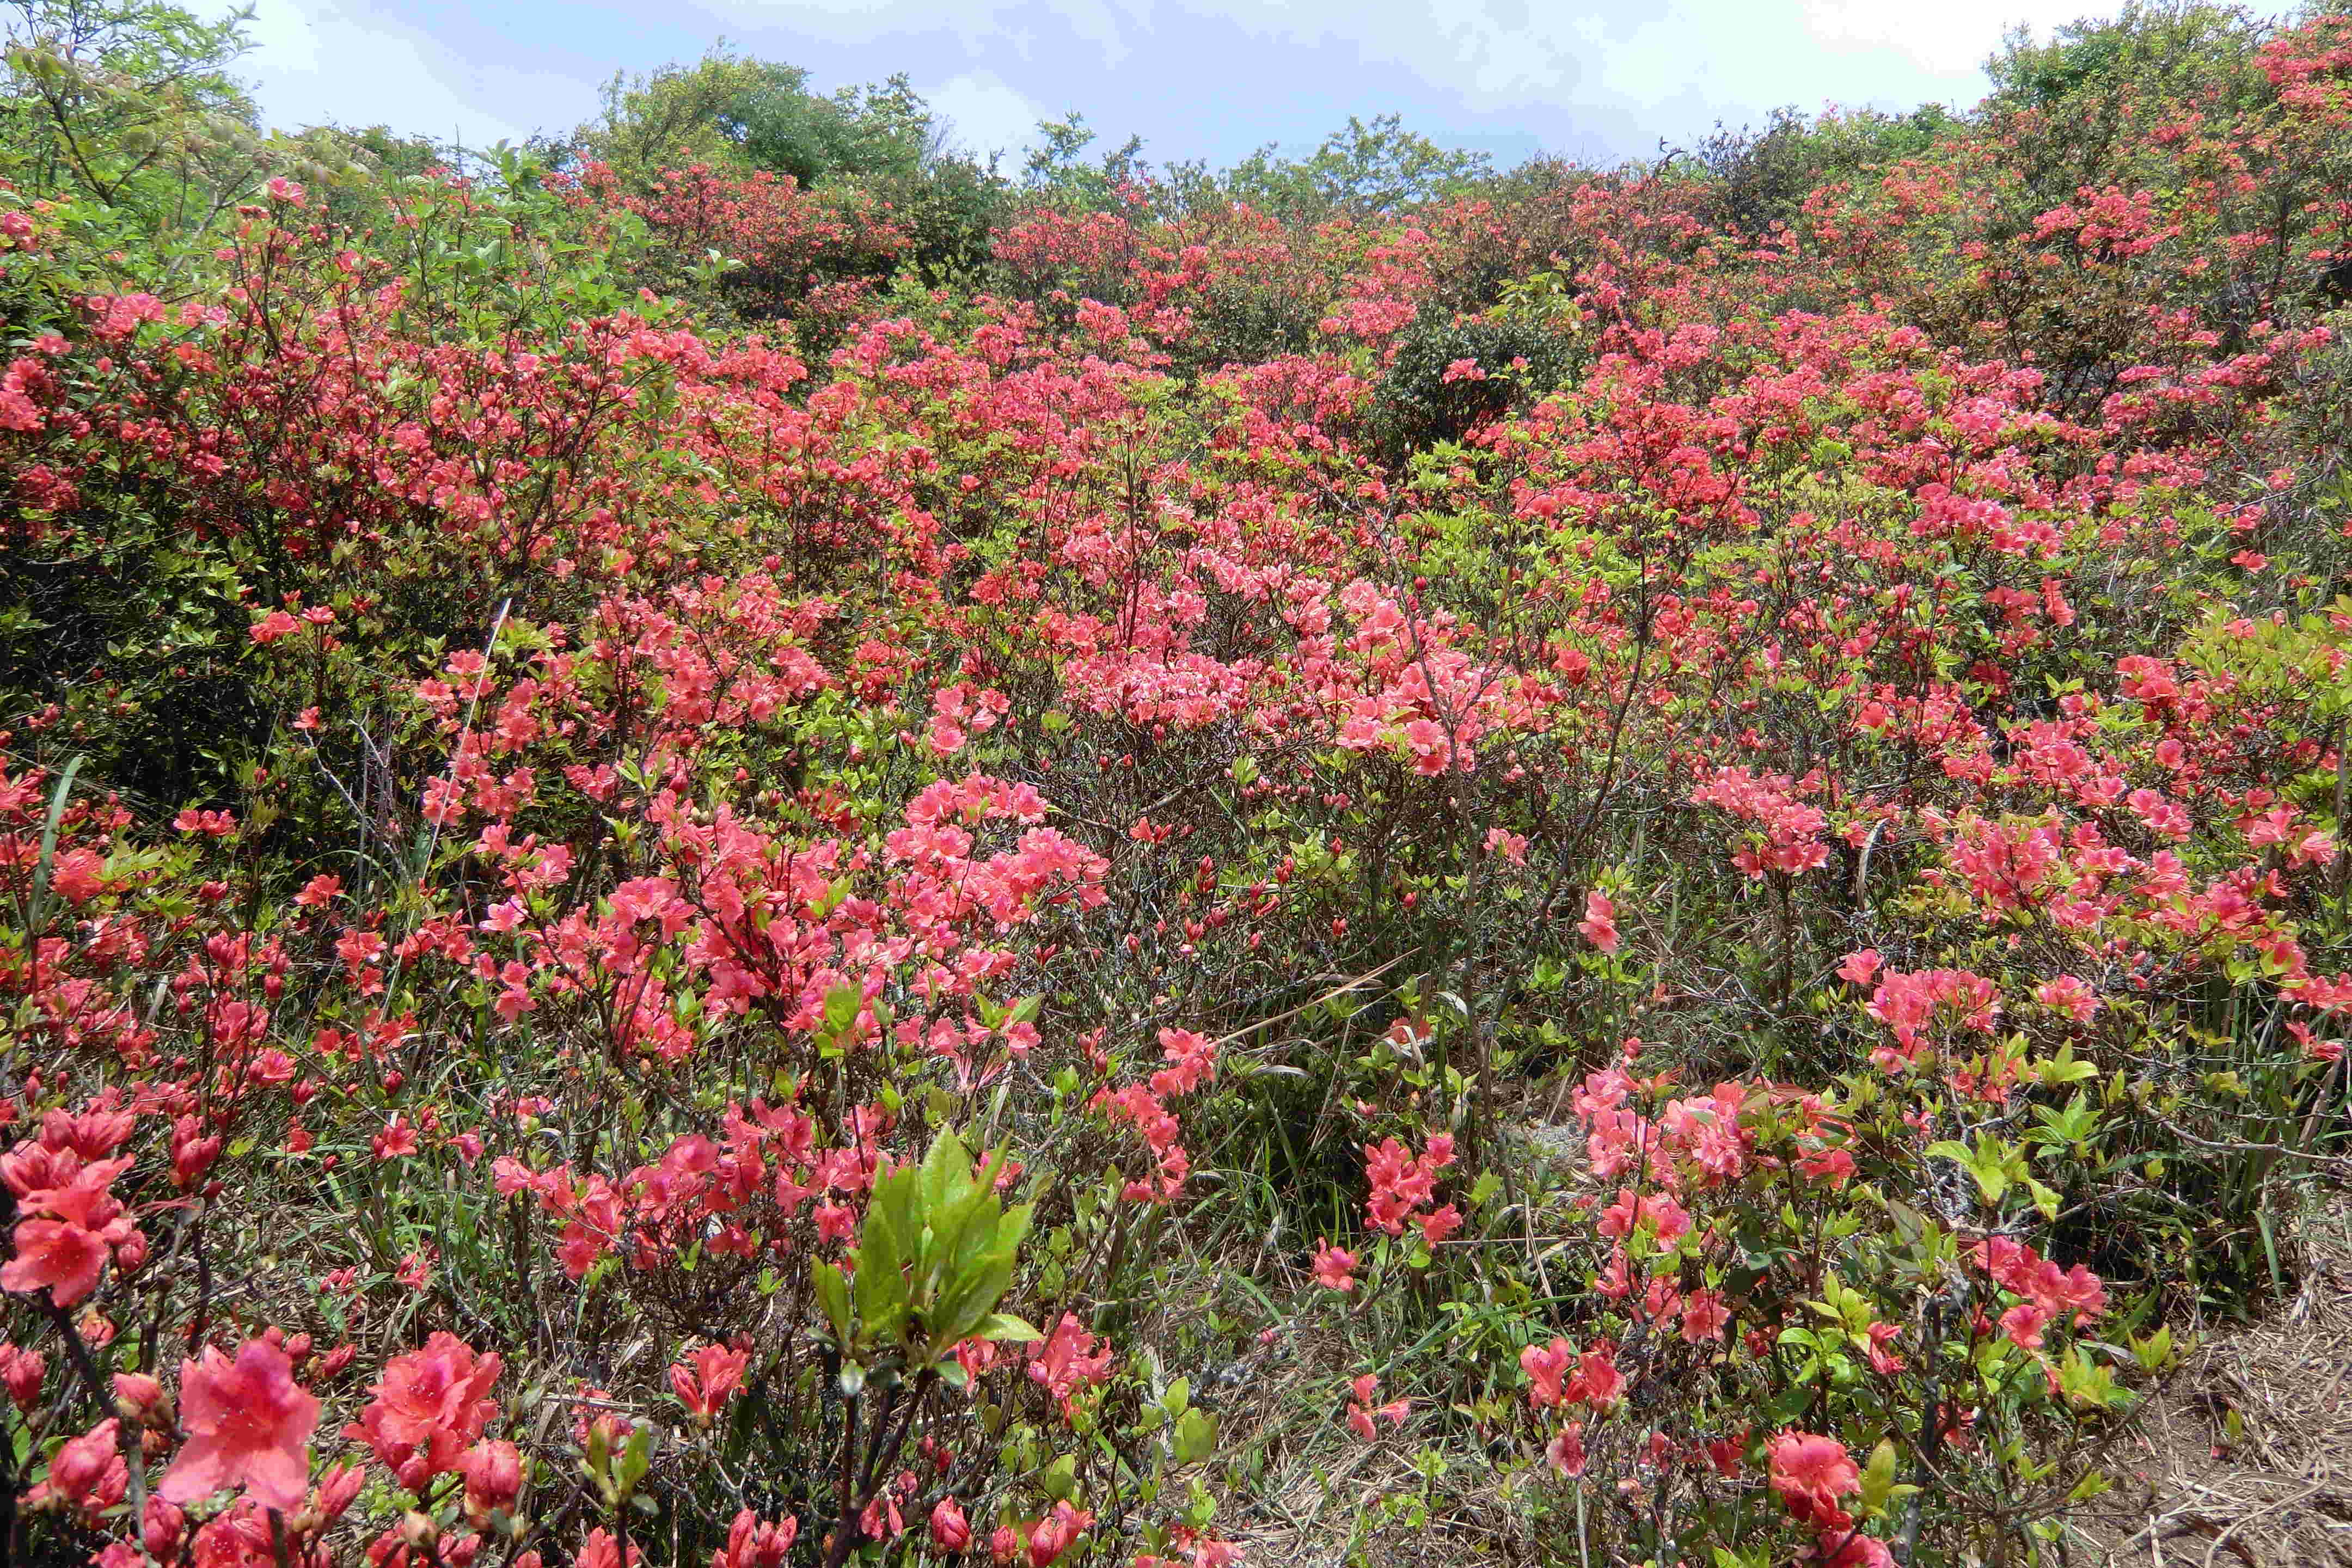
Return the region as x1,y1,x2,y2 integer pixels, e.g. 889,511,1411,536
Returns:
2067,1194,2352,1568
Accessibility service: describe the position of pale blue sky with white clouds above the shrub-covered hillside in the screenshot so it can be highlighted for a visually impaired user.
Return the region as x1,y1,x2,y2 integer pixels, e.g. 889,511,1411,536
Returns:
242,0,2220,164
